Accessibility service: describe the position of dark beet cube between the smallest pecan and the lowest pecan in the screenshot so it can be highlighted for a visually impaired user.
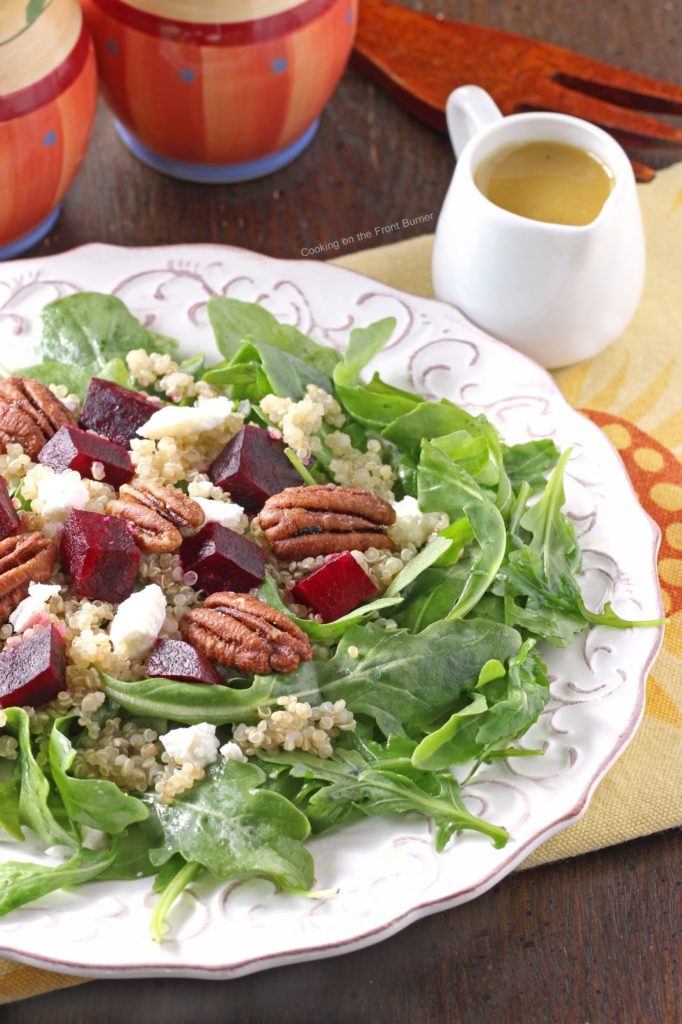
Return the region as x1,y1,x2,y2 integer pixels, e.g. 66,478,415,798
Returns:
180,522,265,594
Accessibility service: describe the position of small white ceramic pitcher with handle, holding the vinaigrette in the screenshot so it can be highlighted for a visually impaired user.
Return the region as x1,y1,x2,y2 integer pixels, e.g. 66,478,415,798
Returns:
433,85,645,368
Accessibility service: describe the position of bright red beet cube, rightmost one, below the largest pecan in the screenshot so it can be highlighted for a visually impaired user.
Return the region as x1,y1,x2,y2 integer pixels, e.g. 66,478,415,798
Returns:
292,551,377,623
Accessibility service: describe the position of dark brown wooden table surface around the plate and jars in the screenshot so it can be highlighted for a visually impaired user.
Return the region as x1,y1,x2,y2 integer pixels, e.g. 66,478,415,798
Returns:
0,0,682,1024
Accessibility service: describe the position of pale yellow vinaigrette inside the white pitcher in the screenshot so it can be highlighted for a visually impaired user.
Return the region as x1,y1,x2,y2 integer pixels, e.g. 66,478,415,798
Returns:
474,142,614,225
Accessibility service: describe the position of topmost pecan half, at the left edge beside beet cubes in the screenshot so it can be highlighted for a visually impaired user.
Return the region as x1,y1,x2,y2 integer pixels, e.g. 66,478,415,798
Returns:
0,377,76,459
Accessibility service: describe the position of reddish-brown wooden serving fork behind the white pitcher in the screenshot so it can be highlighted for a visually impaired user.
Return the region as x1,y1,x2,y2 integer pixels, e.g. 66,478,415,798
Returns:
352,0,682,181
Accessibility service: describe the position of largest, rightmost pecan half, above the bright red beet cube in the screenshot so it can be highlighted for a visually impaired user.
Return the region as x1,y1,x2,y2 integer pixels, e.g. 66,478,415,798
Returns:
258,484,395,562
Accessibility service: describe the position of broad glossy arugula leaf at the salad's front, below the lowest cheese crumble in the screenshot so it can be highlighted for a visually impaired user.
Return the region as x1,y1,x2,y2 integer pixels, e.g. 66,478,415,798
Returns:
150,761,313,891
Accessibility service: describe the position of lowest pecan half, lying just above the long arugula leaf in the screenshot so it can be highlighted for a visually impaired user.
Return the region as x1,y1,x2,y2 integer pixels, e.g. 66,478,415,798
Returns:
180,591,312,675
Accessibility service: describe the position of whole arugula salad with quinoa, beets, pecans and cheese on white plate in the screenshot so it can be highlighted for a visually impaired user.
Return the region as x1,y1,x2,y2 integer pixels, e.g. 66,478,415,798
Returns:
0,293,656,939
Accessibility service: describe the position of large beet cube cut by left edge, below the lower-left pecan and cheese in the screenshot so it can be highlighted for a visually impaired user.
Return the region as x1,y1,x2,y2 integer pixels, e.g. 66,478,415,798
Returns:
0,626,67,708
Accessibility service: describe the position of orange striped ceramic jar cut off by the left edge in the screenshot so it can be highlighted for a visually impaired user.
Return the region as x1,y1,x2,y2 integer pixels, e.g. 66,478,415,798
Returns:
0,0,97,259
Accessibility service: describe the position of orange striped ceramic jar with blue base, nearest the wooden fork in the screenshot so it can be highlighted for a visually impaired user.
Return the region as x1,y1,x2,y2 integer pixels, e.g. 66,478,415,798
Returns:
82,0,357,182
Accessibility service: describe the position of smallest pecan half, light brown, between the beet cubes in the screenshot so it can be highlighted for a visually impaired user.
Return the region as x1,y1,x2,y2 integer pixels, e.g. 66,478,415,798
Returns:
106,483,205,552
